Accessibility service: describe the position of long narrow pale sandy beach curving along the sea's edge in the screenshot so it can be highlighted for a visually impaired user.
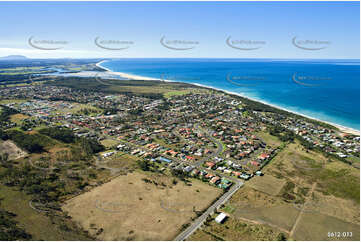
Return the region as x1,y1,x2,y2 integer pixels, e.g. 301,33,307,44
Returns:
95,60,360,136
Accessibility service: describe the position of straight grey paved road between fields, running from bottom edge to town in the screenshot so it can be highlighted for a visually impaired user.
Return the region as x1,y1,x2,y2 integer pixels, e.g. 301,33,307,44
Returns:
174,181,243,241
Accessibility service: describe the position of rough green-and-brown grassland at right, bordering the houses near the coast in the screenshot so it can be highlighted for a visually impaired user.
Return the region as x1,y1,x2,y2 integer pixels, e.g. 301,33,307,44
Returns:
264,143,360,204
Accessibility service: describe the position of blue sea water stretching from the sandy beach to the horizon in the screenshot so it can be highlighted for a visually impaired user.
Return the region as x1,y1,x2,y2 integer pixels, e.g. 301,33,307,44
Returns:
101,59,360,130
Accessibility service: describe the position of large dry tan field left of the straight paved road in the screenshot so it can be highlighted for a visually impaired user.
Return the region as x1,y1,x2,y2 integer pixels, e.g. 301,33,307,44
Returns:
63,172,221,240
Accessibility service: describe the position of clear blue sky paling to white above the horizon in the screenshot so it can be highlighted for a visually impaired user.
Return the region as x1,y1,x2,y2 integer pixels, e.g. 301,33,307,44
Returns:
0,2,360,59
